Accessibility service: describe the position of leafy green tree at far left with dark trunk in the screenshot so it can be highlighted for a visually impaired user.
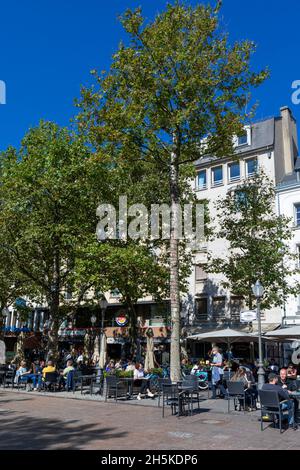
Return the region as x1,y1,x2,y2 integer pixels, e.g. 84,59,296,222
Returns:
0,123,108,351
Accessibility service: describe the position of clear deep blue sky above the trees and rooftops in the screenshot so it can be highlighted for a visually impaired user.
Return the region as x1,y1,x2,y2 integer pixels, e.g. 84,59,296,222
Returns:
0,0,300,150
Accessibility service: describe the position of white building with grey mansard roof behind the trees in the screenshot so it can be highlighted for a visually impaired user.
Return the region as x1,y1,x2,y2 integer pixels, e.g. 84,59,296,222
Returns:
187,107,300,333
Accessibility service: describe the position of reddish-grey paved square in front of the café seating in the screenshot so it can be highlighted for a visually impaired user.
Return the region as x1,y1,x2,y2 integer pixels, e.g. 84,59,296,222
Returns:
0,389,300,450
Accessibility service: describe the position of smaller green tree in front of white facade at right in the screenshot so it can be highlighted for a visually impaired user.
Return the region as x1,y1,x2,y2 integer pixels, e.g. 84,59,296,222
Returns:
208,171,300,308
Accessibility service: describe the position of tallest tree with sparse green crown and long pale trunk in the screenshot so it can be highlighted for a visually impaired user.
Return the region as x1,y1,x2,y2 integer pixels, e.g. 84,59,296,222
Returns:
78,2,267,380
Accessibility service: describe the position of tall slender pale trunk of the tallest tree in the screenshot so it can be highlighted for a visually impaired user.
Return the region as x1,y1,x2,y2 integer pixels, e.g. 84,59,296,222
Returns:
170,142,181,382
